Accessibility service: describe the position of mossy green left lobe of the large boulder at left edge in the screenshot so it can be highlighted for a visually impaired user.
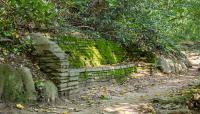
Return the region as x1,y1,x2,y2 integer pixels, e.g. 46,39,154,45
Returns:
0,65,26,102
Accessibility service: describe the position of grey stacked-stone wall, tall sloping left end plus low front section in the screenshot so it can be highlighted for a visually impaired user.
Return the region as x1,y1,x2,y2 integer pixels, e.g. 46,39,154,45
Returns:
31,33,134,98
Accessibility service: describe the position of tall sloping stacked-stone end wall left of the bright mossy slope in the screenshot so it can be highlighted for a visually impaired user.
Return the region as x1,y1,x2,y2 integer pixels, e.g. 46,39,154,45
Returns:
31,33,78,97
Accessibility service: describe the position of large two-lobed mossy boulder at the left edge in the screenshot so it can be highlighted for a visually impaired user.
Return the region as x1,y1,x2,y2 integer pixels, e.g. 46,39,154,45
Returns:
0,64,36,102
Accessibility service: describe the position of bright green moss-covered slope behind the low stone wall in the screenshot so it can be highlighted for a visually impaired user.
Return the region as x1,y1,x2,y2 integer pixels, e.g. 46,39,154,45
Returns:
59,36,126,68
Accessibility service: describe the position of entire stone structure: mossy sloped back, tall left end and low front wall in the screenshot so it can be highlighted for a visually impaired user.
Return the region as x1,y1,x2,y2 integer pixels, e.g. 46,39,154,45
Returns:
31,33,134,98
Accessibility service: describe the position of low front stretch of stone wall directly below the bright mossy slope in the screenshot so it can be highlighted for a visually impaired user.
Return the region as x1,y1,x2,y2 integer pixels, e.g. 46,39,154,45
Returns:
68,64,134,96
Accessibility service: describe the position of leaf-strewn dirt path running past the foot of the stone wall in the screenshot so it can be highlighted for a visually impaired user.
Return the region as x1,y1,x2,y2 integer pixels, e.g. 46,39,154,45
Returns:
0,49,200,114
